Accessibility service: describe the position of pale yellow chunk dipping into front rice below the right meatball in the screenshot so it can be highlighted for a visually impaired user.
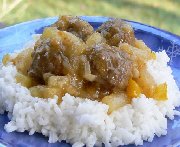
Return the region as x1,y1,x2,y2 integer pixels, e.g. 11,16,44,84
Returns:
102,93,128,114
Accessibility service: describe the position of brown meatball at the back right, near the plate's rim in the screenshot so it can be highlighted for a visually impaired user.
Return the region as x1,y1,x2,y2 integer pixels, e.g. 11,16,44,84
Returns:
97,19,135,46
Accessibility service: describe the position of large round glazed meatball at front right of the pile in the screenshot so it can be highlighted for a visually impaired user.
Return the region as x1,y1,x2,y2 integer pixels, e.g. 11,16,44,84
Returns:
89,44,132,90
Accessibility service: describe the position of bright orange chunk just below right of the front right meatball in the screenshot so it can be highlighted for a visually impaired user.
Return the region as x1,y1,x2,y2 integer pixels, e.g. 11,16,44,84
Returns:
126,79,141,101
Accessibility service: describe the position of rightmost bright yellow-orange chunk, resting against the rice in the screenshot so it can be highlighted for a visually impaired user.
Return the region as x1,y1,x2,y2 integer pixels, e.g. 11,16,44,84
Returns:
153,83,167,101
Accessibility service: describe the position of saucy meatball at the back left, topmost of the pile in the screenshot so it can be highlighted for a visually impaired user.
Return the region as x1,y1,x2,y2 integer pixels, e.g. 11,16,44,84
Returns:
52,15,94,41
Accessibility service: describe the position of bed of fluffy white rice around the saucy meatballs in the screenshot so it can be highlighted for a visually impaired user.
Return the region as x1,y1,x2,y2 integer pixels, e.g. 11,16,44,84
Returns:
0,45,180,147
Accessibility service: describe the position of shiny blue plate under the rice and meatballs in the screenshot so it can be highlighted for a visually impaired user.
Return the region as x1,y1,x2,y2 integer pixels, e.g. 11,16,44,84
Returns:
0,16,180,147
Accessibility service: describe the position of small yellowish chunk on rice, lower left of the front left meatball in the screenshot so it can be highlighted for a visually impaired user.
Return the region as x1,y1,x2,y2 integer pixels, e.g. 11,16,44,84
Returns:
15,73,37,88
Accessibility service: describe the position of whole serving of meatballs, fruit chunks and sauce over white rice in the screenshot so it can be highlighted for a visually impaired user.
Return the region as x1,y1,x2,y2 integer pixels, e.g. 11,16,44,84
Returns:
0,16,180,146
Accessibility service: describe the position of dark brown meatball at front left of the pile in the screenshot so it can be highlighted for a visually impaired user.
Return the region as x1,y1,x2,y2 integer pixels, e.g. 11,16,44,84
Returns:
28,40,63,81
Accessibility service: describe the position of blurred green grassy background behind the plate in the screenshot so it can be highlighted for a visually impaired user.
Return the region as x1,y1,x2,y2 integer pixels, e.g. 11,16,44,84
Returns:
0,0,180,35
